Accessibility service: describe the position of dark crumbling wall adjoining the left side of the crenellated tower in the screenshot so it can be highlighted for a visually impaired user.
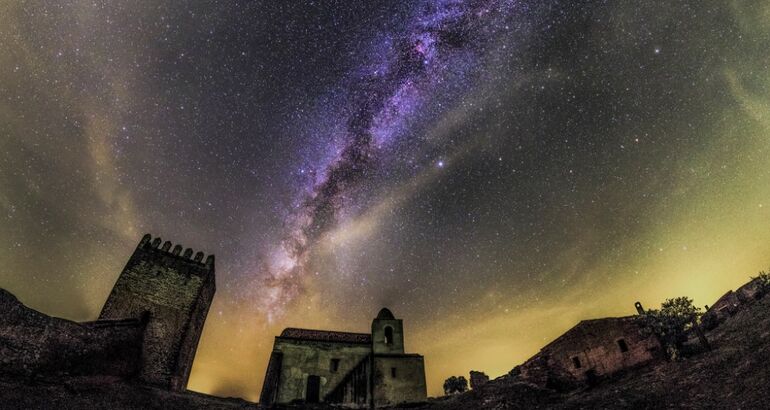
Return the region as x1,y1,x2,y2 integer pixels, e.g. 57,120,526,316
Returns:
0,289,144,378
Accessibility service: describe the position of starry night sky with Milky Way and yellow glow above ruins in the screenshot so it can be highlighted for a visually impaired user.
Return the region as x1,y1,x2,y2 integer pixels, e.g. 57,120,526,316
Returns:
0,0,770,400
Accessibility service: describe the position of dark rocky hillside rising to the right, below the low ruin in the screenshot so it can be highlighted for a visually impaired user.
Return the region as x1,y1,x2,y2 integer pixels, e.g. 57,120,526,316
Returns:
402,297,770,410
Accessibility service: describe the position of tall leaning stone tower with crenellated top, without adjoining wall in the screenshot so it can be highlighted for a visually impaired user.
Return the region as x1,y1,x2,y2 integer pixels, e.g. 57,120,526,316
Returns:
99,234,216,391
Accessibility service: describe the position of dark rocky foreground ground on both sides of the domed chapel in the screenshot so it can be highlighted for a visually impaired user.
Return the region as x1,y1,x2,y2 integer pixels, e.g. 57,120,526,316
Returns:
0,296,770,410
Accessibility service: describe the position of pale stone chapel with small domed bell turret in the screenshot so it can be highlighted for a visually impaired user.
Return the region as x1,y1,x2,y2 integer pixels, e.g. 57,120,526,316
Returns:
259,308,427,407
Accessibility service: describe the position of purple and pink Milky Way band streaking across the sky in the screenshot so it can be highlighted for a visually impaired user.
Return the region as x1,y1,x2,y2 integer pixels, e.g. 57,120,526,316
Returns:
260,0,526,317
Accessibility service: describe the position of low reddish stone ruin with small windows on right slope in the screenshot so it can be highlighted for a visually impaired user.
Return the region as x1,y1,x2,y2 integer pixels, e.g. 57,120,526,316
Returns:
519,314,663,388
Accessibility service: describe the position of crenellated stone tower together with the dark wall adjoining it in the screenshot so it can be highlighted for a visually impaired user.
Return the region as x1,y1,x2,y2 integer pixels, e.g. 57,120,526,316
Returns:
0,234,215,391
